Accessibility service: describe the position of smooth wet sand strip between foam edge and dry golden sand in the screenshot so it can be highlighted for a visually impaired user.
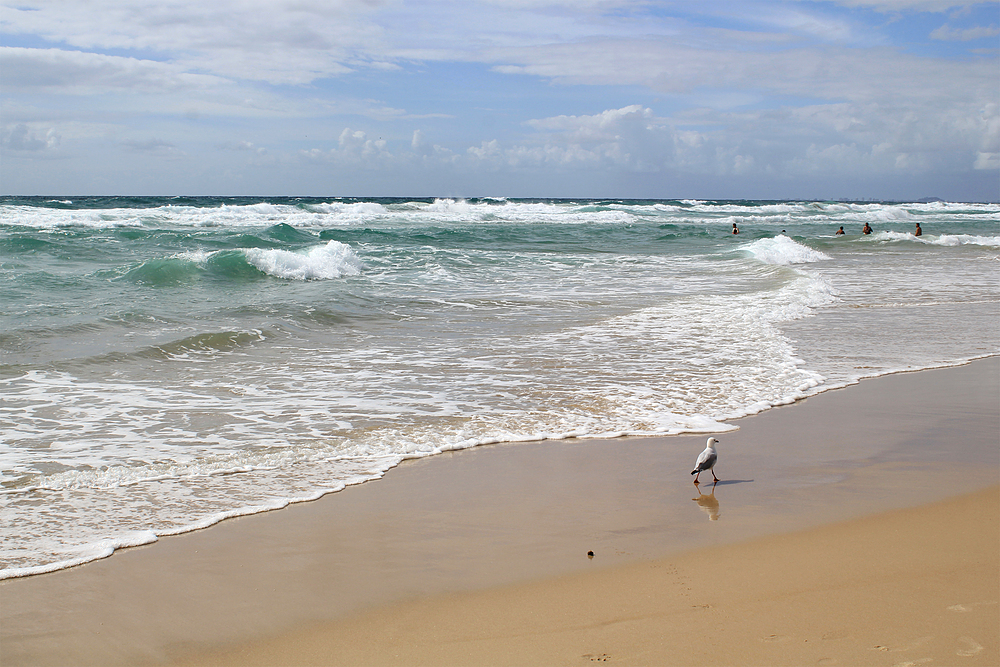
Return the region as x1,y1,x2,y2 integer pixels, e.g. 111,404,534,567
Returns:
0,357,1000,665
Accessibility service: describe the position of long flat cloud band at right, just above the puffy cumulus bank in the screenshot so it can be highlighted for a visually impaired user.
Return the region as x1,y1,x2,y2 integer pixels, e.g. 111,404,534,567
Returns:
486,40,997,108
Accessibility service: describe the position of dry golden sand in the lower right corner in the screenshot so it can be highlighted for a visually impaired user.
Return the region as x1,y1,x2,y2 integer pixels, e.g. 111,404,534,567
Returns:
192,487,1000,666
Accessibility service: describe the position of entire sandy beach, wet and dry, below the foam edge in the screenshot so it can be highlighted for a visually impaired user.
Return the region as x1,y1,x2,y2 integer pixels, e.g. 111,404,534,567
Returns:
0,358,1000,666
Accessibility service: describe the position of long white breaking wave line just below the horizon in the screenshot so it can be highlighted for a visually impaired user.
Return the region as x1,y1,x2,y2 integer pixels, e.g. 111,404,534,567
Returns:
0,198,1000,231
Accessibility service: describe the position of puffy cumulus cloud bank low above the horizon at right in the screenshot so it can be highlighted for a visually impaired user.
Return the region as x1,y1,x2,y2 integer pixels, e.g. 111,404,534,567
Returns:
467,96,1000,179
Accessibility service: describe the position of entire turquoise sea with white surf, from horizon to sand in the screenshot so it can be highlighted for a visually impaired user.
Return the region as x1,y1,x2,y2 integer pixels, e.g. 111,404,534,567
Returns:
0,197,1000,578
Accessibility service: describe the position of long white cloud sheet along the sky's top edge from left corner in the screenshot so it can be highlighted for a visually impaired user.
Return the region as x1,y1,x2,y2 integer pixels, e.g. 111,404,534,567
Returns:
4,0,857,85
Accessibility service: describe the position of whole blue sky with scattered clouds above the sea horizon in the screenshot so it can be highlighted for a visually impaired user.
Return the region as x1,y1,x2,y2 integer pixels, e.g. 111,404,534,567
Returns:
0,0,1000,201
